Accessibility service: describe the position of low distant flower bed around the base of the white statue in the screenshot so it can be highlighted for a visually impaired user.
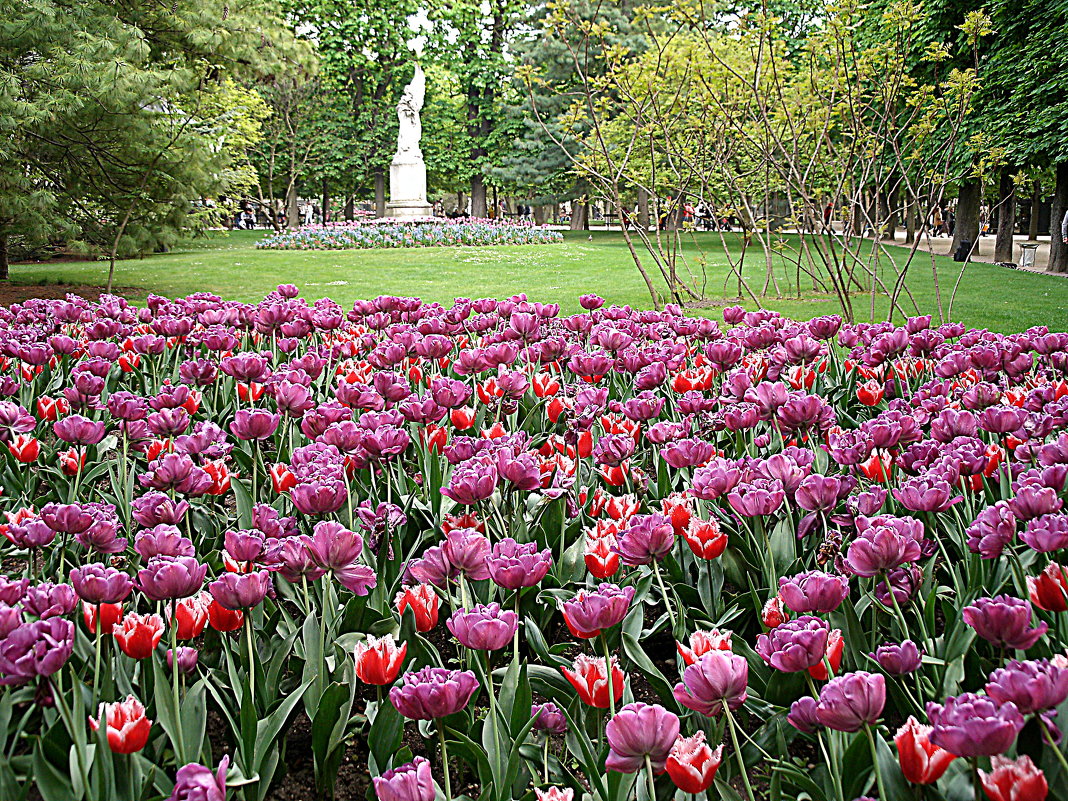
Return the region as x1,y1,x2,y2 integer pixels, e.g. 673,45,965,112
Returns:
256,219,564,250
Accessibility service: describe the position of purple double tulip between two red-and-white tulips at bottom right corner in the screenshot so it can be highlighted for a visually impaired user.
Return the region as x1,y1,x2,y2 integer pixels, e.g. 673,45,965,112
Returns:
927,692,1023,757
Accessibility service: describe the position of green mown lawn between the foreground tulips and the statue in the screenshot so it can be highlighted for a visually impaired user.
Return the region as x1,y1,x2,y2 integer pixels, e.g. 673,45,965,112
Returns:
12,231,1068,332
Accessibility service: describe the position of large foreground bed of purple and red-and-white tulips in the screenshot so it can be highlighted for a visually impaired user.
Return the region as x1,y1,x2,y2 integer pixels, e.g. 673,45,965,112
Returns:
0,286,1068,801
